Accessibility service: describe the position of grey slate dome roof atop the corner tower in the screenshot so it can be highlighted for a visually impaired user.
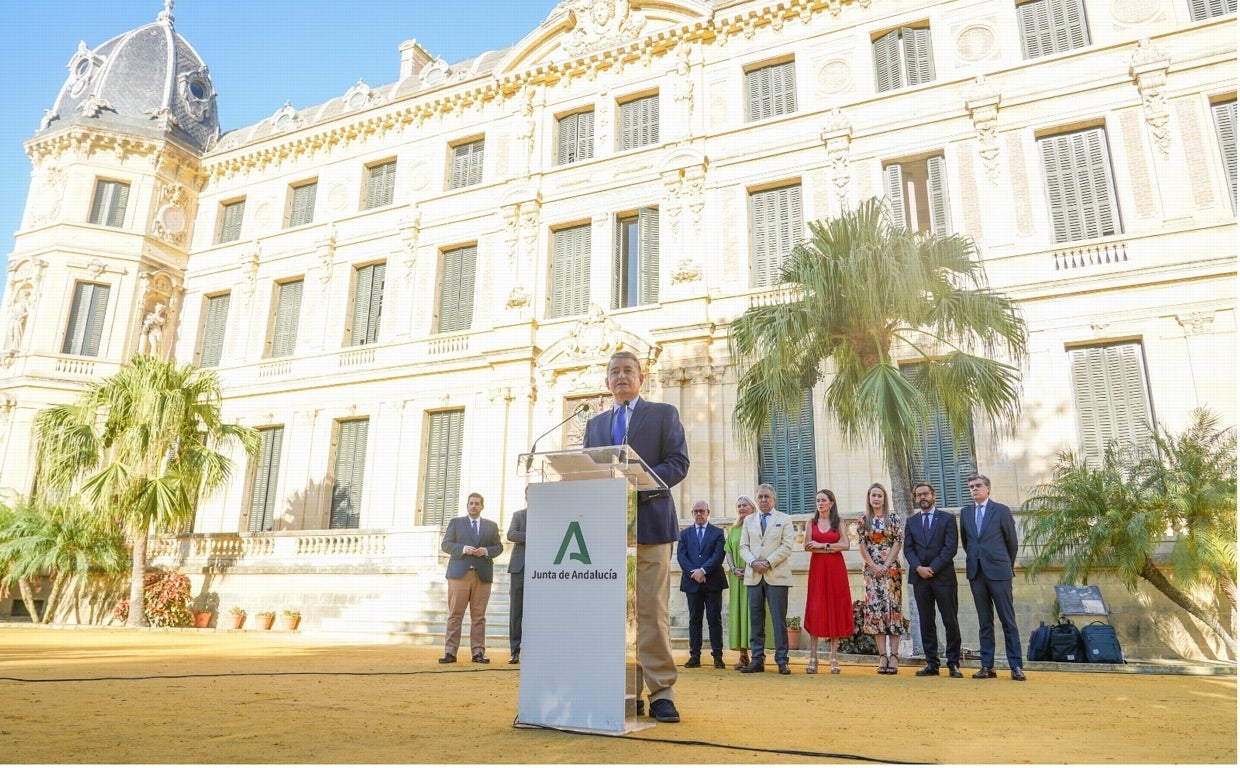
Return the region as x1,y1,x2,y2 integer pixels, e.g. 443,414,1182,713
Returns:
41,4,219,153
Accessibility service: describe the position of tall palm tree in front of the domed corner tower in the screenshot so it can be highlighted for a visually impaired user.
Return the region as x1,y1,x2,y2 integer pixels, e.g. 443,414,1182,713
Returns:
35,355,259,627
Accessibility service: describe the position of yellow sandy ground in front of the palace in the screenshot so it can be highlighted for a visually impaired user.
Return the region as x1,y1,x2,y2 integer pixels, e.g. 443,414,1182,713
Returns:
0,628,1236,764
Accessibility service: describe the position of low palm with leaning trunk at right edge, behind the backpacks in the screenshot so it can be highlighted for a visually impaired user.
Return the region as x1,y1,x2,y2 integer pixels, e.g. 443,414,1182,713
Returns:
1022,422,1236,658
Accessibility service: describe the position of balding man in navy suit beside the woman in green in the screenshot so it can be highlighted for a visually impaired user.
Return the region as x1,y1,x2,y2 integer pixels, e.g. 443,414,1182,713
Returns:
676,501,728,669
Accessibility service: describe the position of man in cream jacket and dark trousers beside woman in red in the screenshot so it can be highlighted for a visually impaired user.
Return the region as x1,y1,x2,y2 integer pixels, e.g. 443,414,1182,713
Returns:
740,483,796,675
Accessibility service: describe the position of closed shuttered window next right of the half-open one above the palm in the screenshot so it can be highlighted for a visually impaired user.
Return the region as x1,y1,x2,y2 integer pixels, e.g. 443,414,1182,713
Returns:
1038,128,1122,243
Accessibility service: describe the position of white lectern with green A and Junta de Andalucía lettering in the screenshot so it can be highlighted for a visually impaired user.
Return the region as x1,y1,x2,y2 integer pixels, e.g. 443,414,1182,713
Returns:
516,445,667,733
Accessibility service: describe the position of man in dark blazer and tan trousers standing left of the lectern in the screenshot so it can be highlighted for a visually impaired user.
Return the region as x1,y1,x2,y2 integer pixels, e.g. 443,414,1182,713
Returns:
439,494,503,664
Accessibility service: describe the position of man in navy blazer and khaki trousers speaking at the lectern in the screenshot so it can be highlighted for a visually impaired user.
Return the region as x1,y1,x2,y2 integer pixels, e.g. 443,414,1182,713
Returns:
585,350,689,722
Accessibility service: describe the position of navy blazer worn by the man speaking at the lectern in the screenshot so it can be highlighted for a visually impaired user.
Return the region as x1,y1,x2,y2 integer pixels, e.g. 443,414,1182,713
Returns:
585,397,689,543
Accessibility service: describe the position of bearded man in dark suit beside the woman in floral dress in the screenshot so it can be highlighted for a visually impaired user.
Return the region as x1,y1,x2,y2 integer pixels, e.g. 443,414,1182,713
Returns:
904,483,963,677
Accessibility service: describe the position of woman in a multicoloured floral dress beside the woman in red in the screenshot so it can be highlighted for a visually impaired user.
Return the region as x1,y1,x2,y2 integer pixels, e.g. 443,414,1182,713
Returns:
857,483,904,675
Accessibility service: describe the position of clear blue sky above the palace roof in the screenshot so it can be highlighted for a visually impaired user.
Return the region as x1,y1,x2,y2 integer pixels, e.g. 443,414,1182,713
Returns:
0,0,557,296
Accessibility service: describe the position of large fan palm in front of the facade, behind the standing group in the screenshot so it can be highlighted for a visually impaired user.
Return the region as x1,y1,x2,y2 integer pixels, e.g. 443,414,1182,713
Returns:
732,199,1027,516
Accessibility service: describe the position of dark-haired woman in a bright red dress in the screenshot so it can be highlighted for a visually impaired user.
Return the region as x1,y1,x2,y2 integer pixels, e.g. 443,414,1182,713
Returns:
805,490,856,675
